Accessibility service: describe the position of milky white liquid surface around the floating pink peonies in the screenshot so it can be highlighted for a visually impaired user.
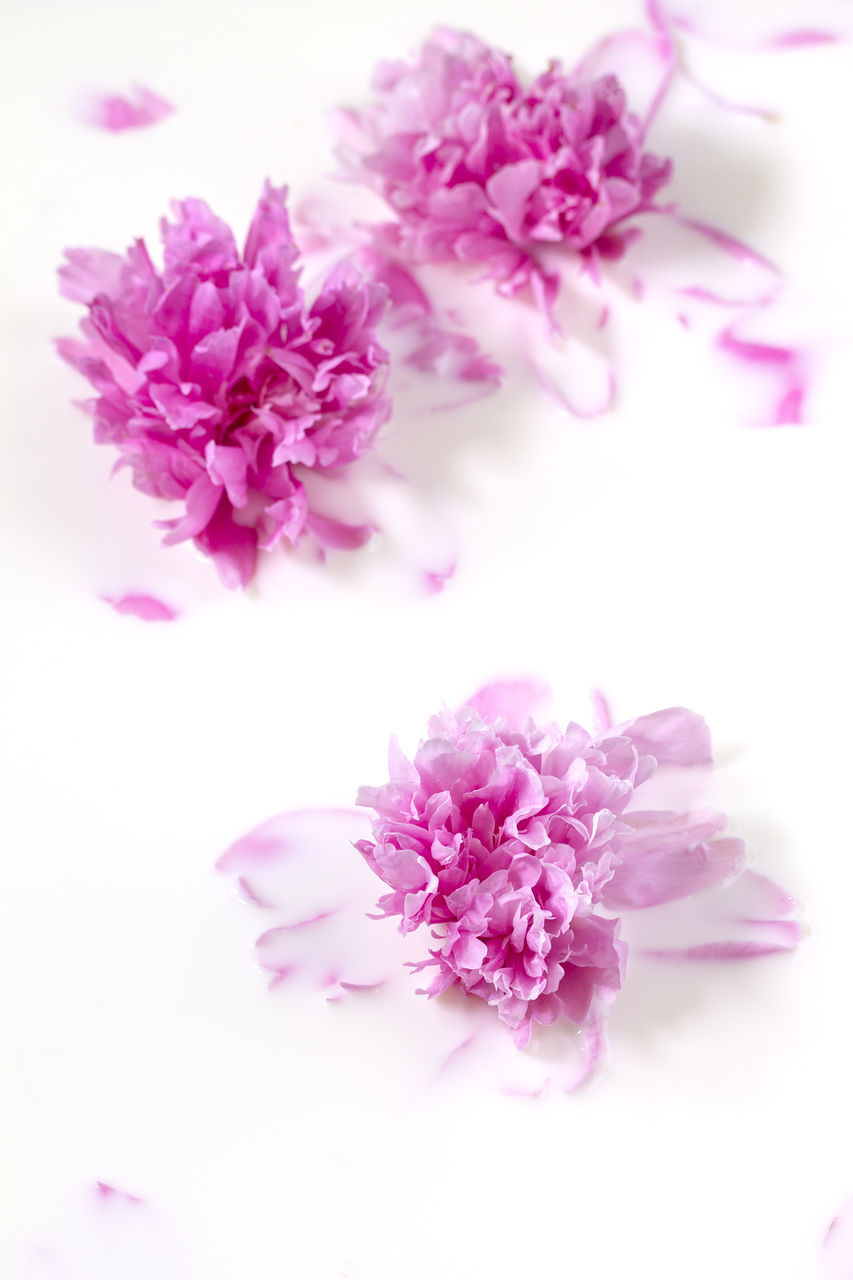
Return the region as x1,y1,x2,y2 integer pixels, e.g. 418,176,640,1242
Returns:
0,0,853,1280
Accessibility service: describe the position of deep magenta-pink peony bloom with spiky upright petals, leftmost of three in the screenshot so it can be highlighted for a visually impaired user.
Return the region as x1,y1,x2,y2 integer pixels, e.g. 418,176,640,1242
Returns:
59,184,389,586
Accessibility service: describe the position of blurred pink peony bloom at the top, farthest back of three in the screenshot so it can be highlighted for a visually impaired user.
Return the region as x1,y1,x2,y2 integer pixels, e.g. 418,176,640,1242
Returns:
345,28,671,307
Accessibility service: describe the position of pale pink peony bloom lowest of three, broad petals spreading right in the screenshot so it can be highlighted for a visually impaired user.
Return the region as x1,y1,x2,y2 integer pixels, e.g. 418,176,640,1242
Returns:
356,686,744,1044
